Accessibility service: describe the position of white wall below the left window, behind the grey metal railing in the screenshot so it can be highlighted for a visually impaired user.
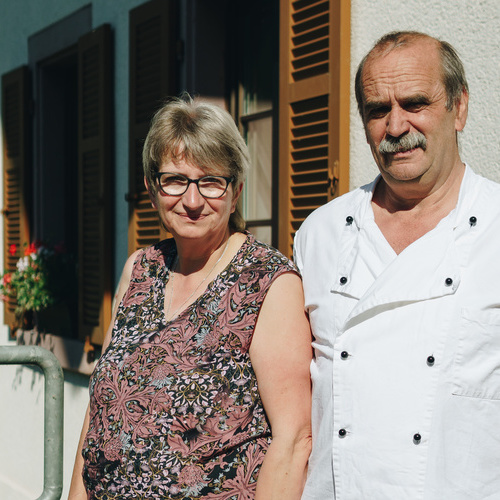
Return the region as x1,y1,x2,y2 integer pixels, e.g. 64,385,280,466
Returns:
0,352,88,500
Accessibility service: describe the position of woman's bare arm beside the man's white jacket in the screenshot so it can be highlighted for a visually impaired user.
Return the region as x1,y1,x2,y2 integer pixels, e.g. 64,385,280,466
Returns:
250,273,312,500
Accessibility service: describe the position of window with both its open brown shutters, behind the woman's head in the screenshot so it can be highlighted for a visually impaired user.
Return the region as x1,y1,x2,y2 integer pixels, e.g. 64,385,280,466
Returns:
123,0,350,255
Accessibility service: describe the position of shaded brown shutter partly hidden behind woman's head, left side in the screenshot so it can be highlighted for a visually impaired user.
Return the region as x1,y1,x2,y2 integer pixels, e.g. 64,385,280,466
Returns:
127,0,178,254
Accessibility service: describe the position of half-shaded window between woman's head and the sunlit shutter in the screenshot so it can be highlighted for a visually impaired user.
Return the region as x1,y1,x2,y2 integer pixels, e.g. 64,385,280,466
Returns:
231,0,279,246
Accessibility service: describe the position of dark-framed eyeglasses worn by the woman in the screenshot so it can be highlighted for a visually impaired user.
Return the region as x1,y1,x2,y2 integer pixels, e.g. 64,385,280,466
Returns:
155,172,234,198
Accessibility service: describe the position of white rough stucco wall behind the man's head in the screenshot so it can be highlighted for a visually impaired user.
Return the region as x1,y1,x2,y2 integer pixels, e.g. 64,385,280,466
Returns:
350,0,500,188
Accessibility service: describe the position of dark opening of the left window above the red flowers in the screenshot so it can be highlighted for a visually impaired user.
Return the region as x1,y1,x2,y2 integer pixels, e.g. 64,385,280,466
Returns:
32,44,79,338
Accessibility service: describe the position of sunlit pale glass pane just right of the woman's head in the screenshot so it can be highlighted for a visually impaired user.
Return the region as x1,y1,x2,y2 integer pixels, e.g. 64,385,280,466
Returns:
243,117,273,220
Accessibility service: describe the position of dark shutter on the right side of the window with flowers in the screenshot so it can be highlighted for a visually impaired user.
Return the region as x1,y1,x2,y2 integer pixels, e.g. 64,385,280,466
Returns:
78,25,113,344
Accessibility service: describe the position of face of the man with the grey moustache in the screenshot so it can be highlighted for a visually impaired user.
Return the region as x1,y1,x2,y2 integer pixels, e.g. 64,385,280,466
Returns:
362,40,467,189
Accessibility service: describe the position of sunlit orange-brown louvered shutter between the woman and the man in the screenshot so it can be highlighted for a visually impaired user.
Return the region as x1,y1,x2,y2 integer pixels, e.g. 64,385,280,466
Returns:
279,0,351,255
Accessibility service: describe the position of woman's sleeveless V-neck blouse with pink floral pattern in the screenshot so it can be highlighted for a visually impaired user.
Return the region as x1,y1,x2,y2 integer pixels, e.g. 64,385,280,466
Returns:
82,234,296,500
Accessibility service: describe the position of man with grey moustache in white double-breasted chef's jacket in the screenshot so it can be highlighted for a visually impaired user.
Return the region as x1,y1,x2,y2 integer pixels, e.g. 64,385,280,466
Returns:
295,32,500,500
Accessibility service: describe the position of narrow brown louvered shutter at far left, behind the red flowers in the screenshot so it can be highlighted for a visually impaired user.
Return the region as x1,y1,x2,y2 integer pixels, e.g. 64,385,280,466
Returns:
2,66,31,325
